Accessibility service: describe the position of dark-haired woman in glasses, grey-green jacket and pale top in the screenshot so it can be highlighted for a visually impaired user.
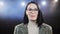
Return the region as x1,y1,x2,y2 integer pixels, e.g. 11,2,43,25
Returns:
14,2,52,34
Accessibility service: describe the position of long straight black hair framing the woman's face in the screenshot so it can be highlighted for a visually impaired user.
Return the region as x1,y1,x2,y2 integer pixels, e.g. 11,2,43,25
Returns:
23,1,44,26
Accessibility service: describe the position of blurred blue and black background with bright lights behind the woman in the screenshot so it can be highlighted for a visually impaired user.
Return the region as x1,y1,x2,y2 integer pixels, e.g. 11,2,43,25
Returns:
0,0,60,34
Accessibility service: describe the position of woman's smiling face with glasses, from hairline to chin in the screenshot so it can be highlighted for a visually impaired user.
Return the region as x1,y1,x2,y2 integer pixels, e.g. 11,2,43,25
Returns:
26,3,38,20
